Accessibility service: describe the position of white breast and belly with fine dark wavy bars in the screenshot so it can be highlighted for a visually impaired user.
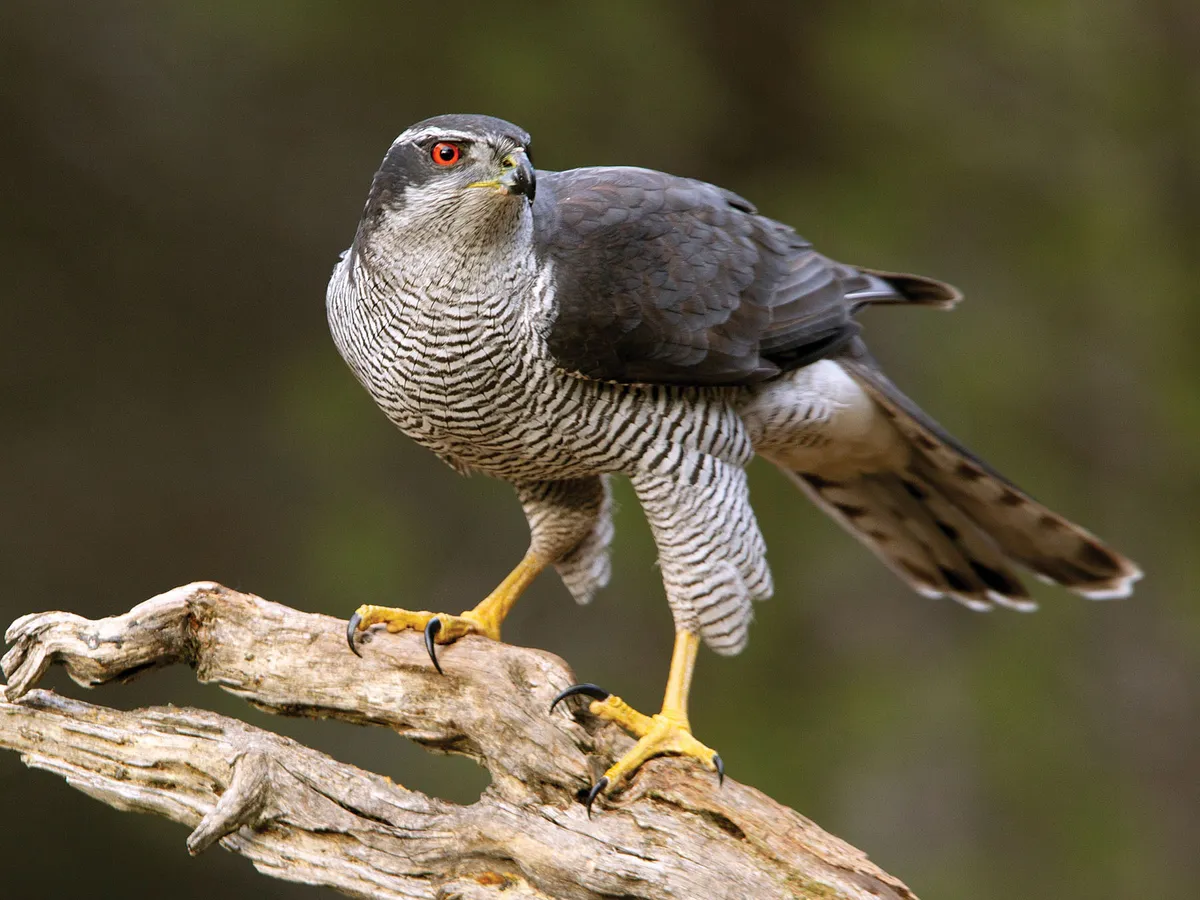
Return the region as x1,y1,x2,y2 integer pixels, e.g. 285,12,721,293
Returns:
328,247,752,481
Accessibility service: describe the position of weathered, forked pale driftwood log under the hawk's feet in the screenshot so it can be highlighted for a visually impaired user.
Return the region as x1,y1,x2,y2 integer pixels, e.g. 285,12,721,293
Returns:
0,582,913,900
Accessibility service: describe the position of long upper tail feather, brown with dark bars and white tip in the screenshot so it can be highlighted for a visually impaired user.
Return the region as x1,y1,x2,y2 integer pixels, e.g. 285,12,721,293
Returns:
839,344,1141,600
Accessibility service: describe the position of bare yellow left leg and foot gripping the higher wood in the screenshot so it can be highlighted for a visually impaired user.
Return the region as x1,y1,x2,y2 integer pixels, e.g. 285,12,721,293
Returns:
346,551,546,672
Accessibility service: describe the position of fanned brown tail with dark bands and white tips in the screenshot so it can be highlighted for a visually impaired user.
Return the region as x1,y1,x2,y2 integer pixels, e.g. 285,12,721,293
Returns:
776,342,1141,610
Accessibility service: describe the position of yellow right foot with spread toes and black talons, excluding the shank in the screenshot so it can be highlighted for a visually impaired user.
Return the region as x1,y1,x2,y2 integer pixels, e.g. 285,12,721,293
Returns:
550,684,725,816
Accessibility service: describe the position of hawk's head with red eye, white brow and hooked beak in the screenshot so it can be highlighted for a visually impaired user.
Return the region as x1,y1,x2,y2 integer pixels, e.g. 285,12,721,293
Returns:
359,115,536,259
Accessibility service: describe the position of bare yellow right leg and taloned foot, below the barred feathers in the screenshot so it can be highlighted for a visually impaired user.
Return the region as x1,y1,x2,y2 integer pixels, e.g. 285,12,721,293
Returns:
551,631,725,815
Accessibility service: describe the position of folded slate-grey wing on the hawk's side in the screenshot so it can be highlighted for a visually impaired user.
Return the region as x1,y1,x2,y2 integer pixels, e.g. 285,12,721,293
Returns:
534,168,946,385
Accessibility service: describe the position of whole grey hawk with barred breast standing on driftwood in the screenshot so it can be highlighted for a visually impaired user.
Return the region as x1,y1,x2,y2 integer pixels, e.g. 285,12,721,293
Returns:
326,115,1141,812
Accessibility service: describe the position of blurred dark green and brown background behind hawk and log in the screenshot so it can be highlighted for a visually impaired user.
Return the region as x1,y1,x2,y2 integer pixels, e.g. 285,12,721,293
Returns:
0,0,1200,900
